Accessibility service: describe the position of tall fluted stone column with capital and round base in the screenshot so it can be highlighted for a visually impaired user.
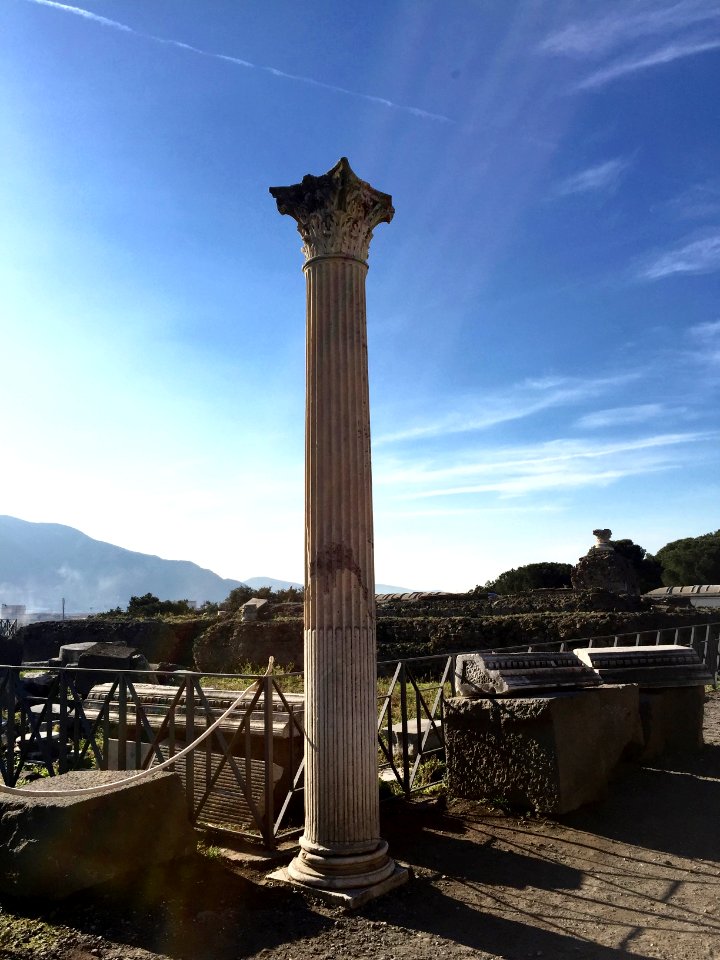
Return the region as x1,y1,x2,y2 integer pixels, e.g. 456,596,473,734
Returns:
270,157,405,891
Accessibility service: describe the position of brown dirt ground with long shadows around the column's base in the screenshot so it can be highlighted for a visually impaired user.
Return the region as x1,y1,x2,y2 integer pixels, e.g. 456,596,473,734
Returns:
0,694,720,960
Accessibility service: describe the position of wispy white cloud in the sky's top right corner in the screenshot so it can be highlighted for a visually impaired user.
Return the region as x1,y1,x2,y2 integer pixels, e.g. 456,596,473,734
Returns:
539,0,720,90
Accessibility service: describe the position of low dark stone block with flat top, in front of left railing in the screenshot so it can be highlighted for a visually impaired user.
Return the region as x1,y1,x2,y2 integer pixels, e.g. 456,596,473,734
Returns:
0,770,195,900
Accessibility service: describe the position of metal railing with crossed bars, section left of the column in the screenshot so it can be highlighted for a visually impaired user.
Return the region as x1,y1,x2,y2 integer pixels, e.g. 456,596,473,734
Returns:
0,667,304,847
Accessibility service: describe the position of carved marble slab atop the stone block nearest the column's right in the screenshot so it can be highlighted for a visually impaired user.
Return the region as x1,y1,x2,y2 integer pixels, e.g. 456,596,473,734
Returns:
455,651,600,697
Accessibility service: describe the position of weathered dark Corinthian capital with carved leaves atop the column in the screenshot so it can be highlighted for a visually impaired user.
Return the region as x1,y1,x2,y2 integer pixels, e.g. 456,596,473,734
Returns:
270,157,395,261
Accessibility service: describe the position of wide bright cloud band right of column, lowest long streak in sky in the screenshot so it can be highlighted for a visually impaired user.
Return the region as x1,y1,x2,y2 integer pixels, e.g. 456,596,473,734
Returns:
375,432,720,501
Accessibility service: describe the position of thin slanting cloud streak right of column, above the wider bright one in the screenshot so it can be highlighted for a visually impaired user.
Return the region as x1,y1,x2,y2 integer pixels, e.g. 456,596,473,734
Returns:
374,372,641,446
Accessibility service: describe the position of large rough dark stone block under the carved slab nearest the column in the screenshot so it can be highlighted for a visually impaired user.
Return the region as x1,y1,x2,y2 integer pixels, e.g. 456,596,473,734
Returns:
445,685,643,814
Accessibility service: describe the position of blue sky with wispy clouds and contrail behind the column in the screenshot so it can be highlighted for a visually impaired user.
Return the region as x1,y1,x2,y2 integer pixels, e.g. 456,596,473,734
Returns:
0,0,720,590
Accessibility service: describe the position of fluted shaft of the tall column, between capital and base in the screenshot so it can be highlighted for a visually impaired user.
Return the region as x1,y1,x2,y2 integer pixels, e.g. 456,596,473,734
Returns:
305,258,379,852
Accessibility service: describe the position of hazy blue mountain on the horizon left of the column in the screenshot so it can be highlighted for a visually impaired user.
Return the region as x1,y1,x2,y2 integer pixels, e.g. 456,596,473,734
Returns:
0,516,242,613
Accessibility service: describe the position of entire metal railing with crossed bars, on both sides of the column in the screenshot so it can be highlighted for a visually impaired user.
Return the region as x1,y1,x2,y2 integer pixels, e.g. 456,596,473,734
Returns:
0,622,720,848
